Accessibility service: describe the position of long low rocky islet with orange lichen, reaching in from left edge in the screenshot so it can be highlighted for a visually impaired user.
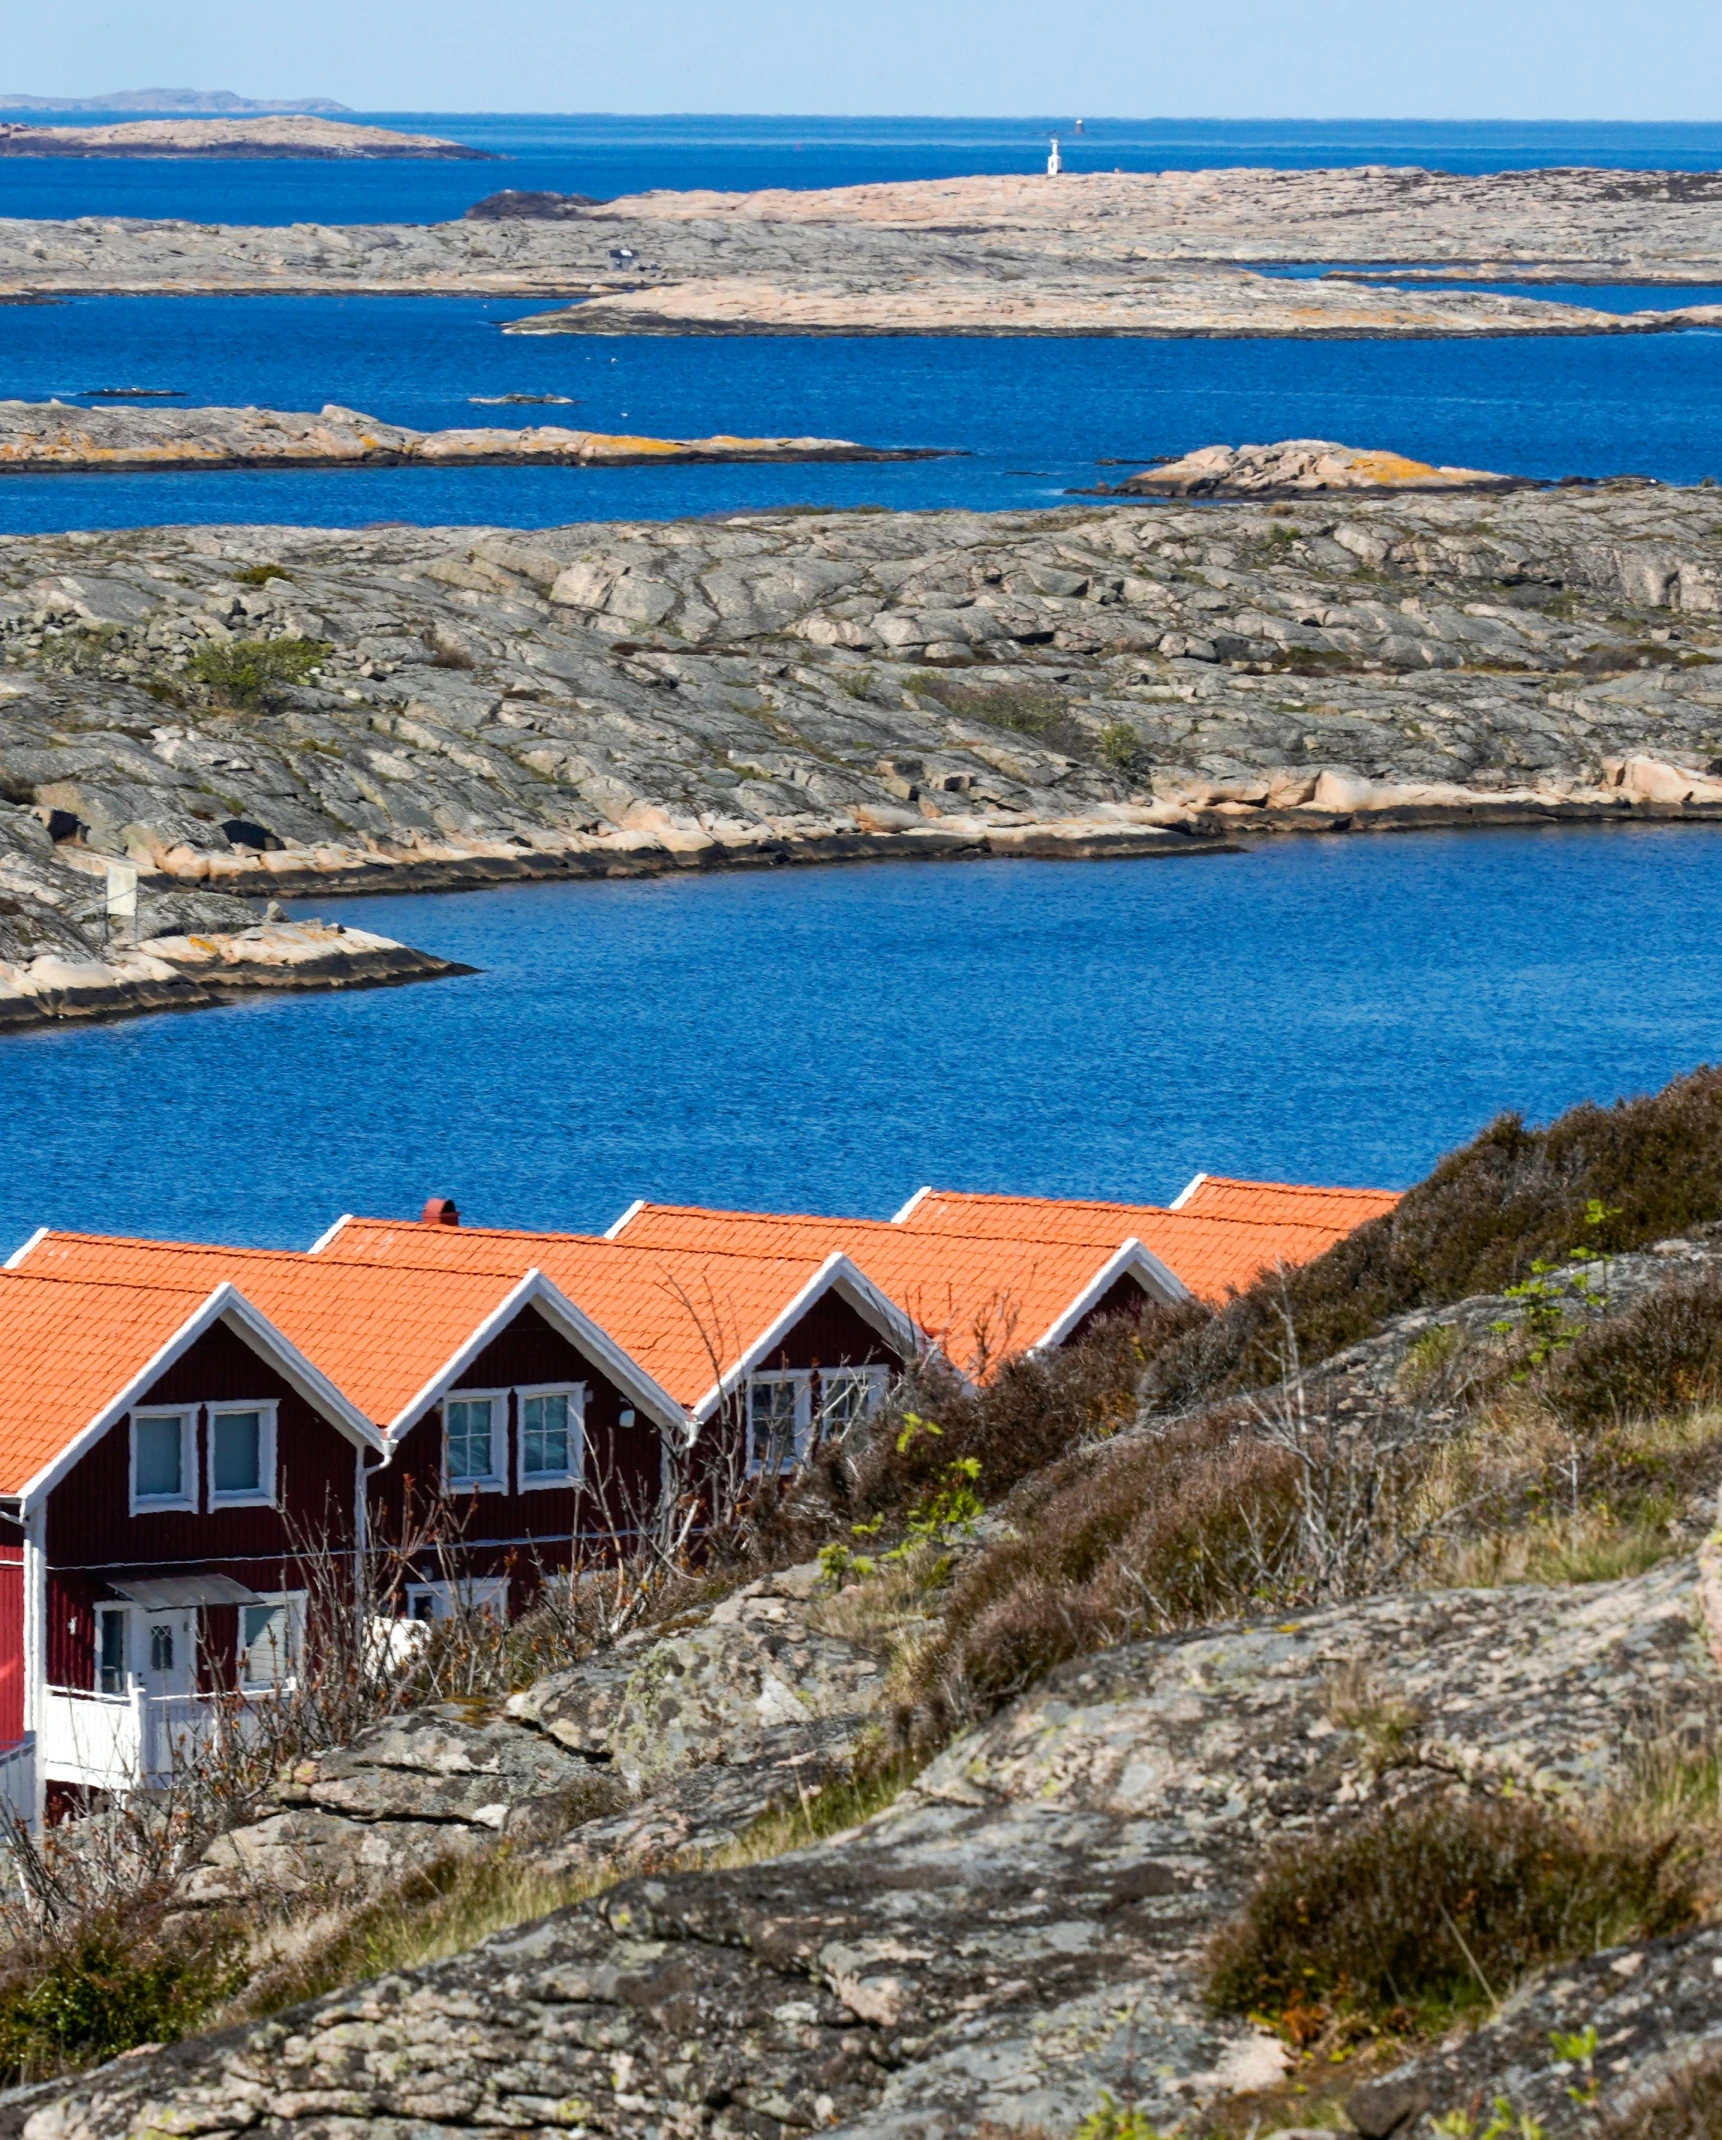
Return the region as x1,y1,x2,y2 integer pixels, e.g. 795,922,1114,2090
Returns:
0,400,939,475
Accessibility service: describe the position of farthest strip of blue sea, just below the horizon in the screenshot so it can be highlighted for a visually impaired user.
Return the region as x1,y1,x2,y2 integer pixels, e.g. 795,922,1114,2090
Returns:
0,111,1722,223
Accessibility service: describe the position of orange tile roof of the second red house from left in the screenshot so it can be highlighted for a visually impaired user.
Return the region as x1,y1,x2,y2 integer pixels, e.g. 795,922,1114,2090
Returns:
19,1233,524,1427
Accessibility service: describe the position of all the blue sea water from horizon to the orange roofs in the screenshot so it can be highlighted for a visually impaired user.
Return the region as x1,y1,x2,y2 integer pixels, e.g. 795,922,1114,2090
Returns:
0,116,1722,1245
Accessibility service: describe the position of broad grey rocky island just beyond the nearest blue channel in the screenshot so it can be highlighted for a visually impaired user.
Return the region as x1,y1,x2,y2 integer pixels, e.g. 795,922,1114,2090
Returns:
0,455,1722,1005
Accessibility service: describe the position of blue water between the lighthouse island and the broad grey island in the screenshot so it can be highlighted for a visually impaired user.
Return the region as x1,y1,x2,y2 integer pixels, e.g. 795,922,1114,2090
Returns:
0,293,1722,533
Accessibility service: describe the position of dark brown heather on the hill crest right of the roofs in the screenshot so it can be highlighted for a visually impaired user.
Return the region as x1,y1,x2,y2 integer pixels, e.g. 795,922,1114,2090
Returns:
1144,1068,1722,1410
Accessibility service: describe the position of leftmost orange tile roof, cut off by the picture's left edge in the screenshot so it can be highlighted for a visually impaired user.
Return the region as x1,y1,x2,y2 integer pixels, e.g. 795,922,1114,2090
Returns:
0,1271,220,1494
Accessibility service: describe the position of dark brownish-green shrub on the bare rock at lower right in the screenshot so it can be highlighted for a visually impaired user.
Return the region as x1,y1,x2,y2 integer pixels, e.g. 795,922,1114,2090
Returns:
1209,1795,1694,2042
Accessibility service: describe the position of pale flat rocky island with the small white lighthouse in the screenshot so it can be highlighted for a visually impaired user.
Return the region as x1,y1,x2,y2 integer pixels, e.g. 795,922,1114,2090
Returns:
0,162,1722,336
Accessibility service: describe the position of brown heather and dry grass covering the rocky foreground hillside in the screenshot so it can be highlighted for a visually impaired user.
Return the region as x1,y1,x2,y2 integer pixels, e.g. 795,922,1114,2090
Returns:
16,1070,1722,2105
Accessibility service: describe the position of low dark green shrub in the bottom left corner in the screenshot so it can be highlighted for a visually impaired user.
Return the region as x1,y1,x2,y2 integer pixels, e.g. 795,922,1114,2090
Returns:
0,1920,242,2084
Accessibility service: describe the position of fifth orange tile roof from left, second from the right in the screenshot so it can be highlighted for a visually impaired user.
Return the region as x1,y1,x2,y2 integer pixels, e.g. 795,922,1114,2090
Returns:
901,1190,1377,1305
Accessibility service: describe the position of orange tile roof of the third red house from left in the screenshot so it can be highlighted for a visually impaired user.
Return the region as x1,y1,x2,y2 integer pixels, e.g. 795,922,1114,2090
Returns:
314,1218,872,1408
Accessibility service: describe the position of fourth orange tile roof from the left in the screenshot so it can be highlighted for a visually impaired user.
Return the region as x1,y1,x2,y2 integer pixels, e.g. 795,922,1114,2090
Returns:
598,1203,1125,1374
